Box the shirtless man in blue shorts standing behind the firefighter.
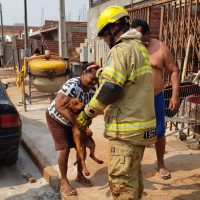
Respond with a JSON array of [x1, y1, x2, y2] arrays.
[[131, 19, 180, 180]]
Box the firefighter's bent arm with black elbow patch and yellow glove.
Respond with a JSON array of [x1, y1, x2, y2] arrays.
[[77, 47, 127, 127]]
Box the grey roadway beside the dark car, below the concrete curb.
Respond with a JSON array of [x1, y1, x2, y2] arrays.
[[0, 147, 59, 200]]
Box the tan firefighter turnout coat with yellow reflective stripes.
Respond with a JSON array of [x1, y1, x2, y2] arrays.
[[86, 29, 156, 145]]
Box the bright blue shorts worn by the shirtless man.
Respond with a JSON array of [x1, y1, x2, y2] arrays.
[[154, 92, 165, 136]]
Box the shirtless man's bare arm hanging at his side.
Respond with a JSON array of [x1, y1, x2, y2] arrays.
[[162, 43, 180, 111]]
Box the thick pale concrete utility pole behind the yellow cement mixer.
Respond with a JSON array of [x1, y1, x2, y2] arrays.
[[59, 0, 67, 57]]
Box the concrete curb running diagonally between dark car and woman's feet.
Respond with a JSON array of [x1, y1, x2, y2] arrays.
[[22, 133, 60, 191]]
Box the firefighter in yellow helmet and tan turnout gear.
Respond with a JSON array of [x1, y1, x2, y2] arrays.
[[77, 6, 156, 200]]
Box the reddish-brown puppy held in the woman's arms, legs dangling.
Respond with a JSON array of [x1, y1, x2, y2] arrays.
[[67, 98, 103, 176]]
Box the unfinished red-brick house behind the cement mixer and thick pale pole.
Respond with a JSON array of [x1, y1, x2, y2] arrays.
[[24, 20, 87, 55]]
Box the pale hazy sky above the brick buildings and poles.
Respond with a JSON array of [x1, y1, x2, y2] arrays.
[[0, 0, 89, 26]]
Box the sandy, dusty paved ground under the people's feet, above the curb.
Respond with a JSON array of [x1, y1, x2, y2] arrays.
[[5, 82, 200, 200]]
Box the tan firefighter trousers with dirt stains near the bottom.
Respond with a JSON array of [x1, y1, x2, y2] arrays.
[[108, 140, 145, 200]]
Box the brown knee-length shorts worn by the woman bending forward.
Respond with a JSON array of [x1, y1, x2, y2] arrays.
[[46, 111, 75, 151]]
